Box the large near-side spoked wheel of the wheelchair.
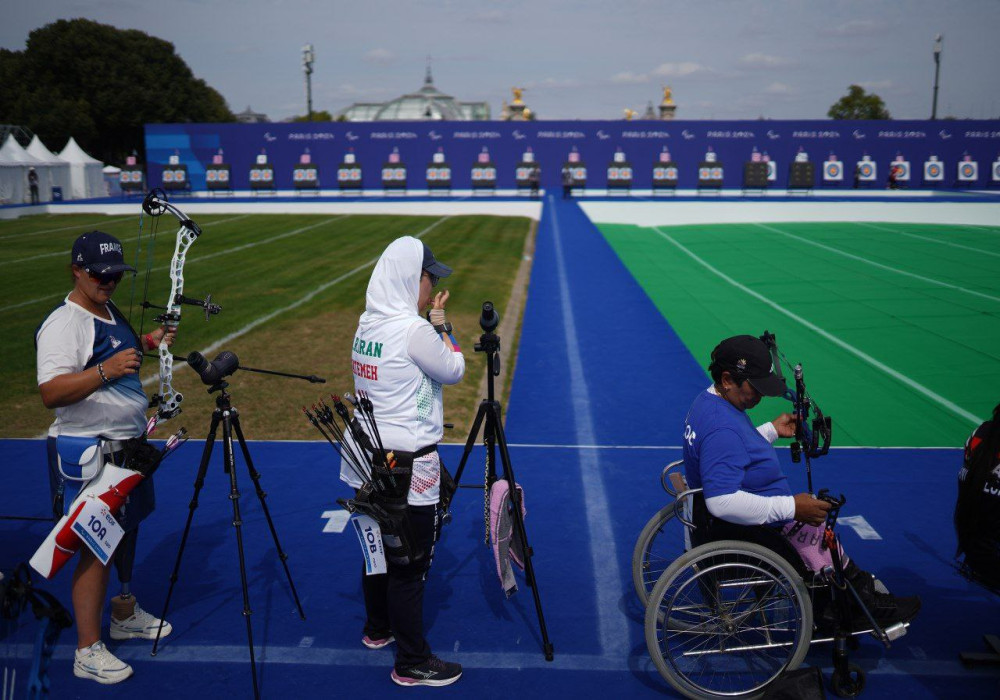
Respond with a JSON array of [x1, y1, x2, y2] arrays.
[[646, 540, 813, 698]]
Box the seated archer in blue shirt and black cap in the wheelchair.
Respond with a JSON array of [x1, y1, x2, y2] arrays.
[[683, 335, 920, 626]]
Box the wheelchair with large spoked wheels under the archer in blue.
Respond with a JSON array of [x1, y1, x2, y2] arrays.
[[632, 461, 909, 699]]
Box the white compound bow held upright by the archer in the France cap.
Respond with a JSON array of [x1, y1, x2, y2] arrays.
[[129, 189, 222, 434]]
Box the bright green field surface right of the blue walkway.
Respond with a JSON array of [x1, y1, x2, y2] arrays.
[[600, 223, 1000, 447]]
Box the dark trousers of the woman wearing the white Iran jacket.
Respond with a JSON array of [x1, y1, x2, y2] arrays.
[[361, 505, 438, 669]]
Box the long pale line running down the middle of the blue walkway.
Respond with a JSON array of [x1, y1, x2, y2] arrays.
[[546, 195, 629, 654]]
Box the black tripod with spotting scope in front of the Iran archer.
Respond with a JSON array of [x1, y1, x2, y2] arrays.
[[455, 302, 553, 661]]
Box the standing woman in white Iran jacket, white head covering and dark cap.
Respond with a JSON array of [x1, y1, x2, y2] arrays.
[[341, 236, 465, 686]]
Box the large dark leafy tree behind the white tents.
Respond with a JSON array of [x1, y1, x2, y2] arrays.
[[0, 19, 234, 163]]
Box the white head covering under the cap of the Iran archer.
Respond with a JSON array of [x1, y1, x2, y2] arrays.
[[360, 236, 424, 328]]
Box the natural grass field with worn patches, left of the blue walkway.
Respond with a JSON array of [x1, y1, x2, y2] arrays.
[[0, 213, 531, 439]]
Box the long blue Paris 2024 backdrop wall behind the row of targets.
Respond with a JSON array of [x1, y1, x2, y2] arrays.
[[146, 120, 1000, 191]]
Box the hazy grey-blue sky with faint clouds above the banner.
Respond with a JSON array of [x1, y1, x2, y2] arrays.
[[0, 0, 1000, 120]]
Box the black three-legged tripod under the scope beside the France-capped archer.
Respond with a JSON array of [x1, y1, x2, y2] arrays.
[[152, 382, 306, 698]]
